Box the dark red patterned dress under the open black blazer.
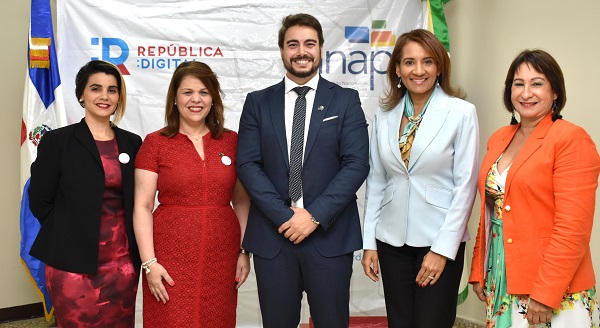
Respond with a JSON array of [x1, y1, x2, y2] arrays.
[[46, 139, 139, 328]]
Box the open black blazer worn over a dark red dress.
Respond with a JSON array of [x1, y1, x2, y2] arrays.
[[29, 120, 142, 274]]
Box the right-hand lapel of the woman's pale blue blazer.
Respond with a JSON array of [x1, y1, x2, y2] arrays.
[[408, 87, 450, 171]]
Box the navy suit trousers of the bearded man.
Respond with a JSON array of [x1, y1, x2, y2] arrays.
[[254, 239, 352, 328]]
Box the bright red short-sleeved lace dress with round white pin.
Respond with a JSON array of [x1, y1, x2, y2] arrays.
[[135, 131, 240, 328]]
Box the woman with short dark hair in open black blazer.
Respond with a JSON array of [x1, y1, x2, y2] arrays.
[[29, 60, 142, 327]]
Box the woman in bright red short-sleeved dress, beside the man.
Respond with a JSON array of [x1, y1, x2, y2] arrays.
[[134, 62, 250, 328]]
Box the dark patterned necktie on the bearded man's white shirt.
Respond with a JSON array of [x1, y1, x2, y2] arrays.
[[289, 87, 310, 202]]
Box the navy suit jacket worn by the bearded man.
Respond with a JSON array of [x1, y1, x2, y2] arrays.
[[236, 78, 369, 259]]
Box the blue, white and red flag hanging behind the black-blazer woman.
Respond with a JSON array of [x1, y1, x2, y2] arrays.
[[21, 0, 66, 320]]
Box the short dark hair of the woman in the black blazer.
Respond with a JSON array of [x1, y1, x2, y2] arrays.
[[75, 60, 127, 124]]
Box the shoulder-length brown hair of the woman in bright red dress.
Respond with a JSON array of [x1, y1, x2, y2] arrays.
[[161, 61, 226, 139]]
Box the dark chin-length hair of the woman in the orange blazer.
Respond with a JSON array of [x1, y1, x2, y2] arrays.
[[503, 49, 567, 121]]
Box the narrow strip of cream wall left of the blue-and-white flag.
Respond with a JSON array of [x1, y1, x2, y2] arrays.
[[0, 0, 39, 309]]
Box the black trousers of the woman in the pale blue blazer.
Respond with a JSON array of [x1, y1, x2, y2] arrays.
[[377, 240, 465, 328]]
